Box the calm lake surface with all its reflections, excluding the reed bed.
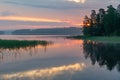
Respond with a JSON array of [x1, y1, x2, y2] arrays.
[[0, 35, 120, 80]]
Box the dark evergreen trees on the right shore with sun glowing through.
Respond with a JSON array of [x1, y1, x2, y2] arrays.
[[83, 4, 120, 36]]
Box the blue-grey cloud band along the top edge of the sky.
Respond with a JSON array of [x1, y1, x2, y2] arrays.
[[4, 0, 85, 9]]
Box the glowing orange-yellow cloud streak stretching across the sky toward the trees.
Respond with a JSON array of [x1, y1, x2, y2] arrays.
[[0, 16, 82, 26]]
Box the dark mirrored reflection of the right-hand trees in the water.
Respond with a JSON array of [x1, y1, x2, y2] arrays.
[[83, 41, 120, 72]]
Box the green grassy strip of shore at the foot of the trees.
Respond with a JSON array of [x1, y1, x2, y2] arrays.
[[68, 36, 120, 43]]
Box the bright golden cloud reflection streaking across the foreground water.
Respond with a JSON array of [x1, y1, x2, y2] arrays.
[[0, 63, 86, 80]]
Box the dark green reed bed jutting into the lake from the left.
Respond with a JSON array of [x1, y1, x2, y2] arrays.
[[0, 39, 50, 49]]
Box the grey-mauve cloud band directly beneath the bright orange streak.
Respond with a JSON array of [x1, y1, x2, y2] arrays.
[[0, 20, 69, 27]]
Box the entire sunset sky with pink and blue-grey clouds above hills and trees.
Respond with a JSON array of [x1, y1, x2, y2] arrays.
[[0, 0, 120, 30]]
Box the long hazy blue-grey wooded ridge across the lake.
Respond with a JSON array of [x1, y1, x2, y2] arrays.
[[11, 27, 82, 35]]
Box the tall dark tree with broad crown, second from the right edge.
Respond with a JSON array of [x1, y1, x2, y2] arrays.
[[104, 5, 117, 36]]
